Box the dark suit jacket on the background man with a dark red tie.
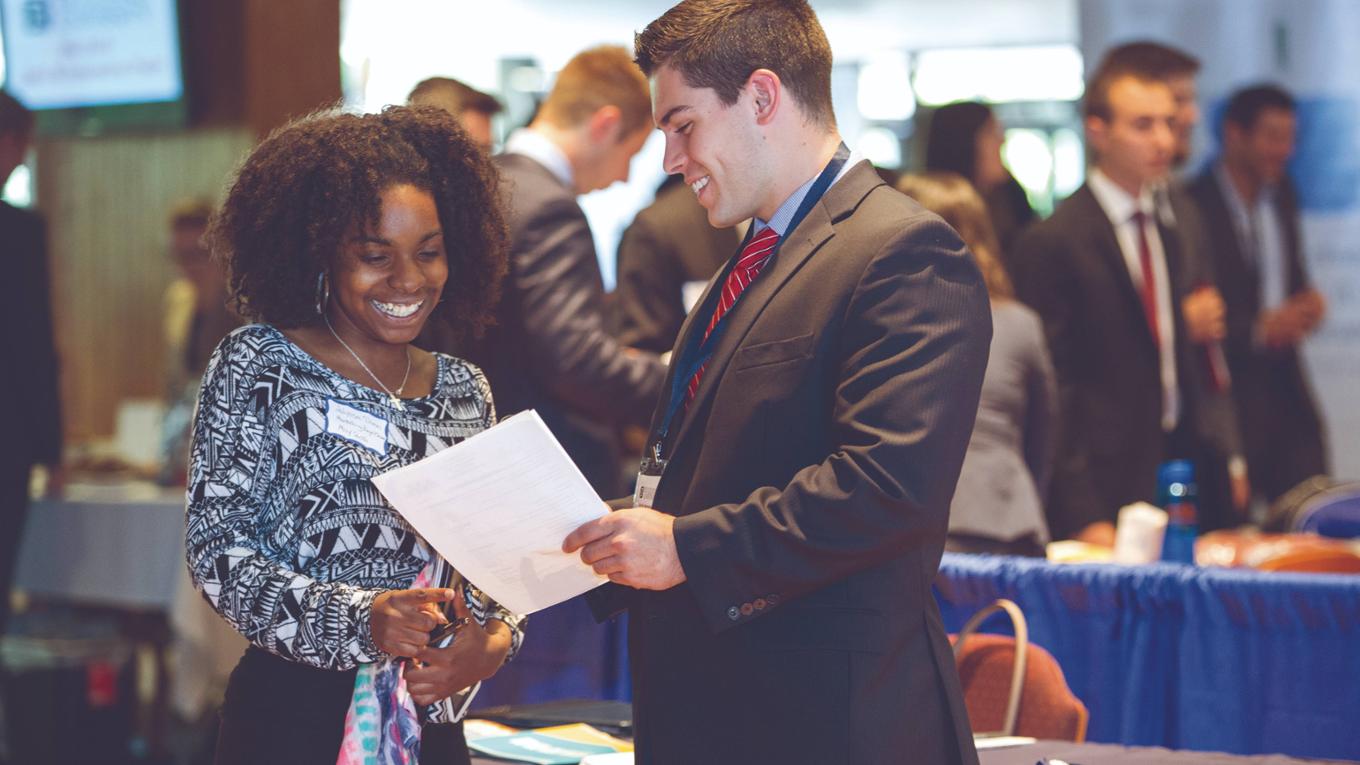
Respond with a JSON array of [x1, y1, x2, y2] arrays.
[[1012, 185, 1236, 539]]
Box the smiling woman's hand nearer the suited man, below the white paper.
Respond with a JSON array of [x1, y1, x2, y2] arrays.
[[405, 591, 510, 705]]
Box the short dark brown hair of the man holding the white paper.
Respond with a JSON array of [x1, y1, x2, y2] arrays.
[[634, 0, 836, 125]]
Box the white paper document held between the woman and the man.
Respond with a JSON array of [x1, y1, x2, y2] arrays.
[[373, 410, 608, 614]]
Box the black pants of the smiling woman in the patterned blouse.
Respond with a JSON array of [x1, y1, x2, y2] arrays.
[[214, 647, 471, 765]]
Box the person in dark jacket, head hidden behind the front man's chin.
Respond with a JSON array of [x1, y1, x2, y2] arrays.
[[613, 176, 741, 354]]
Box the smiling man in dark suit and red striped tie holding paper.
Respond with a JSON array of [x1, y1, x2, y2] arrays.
[[564, 0, 991, 765]]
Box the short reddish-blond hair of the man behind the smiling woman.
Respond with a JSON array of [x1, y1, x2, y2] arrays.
[[539, 45, 651, 135]]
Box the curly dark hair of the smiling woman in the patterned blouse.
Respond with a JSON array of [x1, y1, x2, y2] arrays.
[[208, 106, 507, 338]]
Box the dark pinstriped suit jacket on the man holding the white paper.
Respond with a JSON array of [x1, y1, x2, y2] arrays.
[[597, 163, 991, 765]]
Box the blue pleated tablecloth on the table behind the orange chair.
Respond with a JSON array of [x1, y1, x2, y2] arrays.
[[936, 554, 1360, 760]]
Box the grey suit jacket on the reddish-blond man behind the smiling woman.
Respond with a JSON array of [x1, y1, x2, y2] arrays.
[[427, 154, 665, 497]]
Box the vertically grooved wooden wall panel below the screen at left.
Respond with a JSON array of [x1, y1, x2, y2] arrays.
[[38, 125, 253, 442]]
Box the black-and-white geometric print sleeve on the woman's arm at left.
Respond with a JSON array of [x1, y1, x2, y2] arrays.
[[185, 328, 389, 670]]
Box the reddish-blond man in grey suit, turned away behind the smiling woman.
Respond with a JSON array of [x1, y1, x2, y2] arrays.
[[426, 46, 665, 497]]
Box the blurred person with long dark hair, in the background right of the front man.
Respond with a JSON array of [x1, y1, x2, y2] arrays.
[[926, 101, 1035, 257]]
